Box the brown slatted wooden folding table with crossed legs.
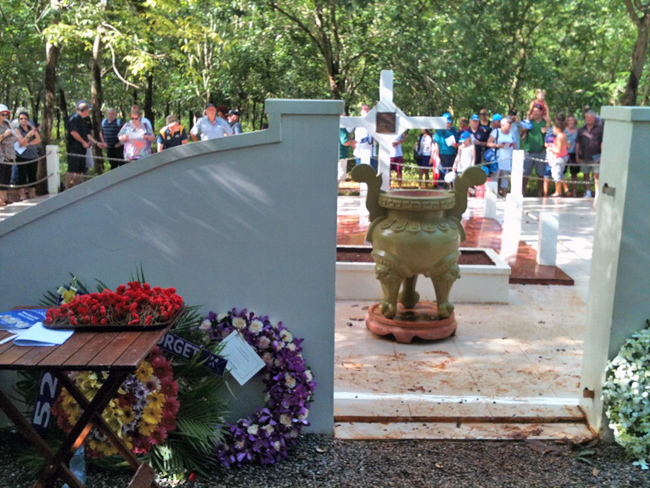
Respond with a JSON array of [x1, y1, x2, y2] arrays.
[[0, 326, 169, 488]]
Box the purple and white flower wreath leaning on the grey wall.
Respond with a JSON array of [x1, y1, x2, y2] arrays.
[[200, 309, 316, 466]]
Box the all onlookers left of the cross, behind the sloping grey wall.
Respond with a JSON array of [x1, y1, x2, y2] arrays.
[[0, 101, 243, 202]]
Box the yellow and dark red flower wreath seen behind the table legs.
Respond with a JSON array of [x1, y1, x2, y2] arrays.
[[52, 348, 180, 458]]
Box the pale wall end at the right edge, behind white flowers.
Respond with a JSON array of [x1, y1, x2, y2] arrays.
[[580, 107, 650, 437]]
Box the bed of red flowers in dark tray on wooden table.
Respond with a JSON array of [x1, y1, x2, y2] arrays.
[[45, 281, 183, 325]]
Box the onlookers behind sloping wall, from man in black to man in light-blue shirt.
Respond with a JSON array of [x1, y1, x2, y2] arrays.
[[65, 101, 243, 189]]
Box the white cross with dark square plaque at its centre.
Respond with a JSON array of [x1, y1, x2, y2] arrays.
[[341, 70, 447, 190]]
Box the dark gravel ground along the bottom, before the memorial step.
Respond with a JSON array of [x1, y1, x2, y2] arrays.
[[0, 435, 650, 488]]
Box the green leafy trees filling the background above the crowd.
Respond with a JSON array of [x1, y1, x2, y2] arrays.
[[0, 0, 650, 137]]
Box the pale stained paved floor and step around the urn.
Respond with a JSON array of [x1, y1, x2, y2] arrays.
[[334, 197, 595, 439]]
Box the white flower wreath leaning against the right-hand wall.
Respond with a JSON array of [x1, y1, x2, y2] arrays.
[[603, 329, 650, 469]]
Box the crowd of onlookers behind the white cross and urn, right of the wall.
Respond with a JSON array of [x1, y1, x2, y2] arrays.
[[338, 89, 603, 197]]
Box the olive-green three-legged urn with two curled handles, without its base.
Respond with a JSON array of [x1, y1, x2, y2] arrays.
[[352, 165, 486, 319]]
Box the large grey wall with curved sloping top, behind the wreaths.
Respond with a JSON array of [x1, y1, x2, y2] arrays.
[[0, 100, 343, 433]]
